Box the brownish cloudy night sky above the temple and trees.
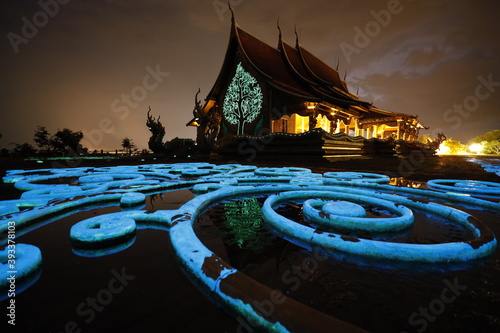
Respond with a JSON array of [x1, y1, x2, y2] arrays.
[[0, 0, 500, 150]]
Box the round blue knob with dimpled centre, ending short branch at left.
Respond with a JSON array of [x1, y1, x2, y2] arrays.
[[70, 215, 137, 248]]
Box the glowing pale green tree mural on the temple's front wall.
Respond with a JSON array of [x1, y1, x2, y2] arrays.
[[222, 62, 262, 135]]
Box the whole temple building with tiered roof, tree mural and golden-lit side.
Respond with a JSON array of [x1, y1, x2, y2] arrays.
[[188, 9, 424, 155]]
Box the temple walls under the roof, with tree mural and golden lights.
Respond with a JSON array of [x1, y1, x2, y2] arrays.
[[214, 56, 418, 140]]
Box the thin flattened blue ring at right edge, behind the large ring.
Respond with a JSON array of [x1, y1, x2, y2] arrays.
[[427, 179, 500, 197]]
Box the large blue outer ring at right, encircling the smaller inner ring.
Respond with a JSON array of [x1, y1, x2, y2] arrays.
[[262, 191, 497, 263]]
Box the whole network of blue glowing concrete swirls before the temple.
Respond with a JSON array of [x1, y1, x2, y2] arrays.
[[0, 163, 500, 332]]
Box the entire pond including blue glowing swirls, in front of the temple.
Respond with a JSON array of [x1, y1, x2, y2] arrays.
[[0, 163, 500, 332]]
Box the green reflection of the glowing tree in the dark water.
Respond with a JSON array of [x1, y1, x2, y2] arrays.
[[223, 198, 270, 250]]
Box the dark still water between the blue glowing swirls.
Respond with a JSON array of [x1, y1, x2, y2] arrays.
[[0, 162, 500, 332]]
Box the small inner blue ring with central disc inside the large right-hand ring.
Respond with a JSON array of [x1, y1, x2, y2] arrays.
[[302, 192, 413, 232]]
